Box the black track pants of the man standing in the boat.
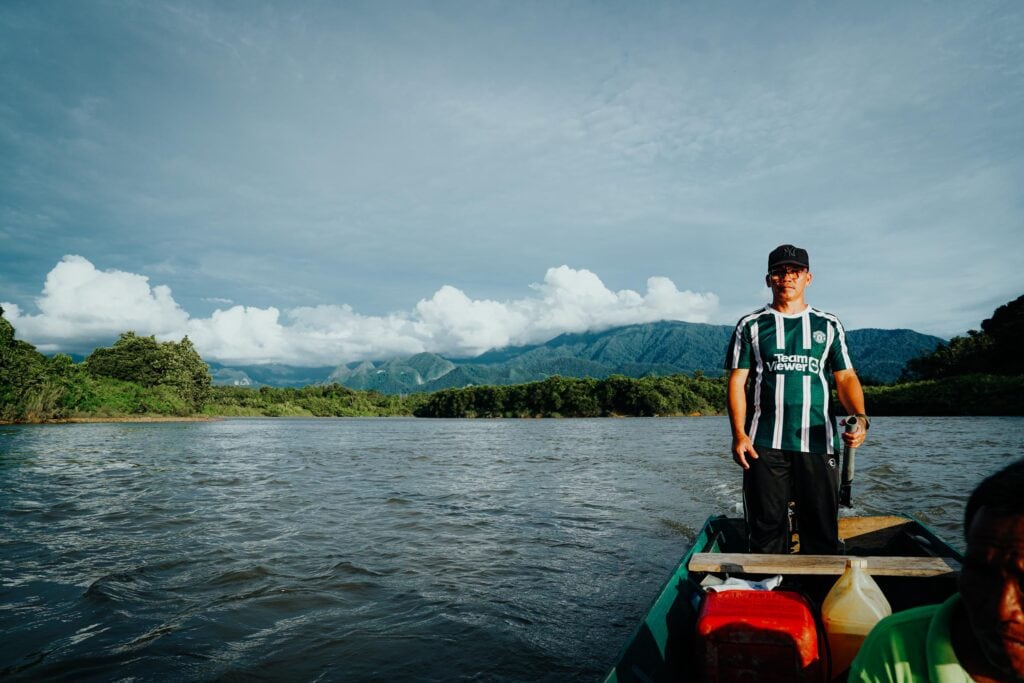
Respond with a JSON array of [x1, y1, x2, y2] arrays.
[[743, 447, 840, 555]]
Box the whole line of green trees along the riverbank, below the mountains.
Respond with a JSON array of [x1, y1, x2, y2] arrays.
[[0, 296, 1024, 423]]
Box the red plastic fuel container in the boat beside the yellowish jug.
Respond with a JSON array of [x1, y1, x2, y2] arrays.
[[696, 591, 825, 683]]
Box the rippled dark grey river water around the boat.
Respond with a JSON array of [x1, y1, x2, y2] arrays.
[[0, 418, 1024, 681]]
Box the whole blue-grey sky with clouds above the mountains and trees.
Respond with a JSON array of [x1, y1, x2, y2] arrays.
[[0, 0, 1024, 365]]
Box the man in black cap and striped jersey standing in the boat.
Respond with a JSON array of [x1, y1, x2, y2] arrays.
[[725, 245, 868, 554]]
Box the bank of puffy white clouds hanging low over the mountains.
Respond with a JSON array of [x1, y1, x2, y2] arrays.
[[3, 255, 718, 366]]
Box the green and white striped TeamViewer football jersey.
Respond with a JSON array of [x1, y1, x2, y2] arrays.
[[725, 306, 853, 454]]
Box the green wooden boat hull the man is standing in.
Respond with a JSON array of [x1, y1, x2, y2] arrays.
[[605, 516, 964, 683]]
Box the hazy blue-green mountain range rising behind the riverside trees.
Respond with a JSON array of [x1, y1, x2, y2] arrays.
[[210, 322, 944, 393]]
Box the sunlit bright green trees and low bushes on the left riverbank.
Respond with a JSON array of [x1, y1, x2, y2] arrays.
[[0, 309, 425, 423]]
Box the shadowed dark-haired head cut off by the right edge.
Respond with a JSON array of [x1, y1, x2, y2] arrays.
[[961, 460, 1024, 680]]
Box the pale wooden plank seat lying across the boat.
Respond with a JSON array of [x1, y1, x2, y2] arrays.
[[689, 553, 961, 577]]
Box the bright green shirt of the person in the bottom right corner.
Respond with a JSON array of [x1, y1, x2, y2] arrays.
[[847, 593, 972, 683]]
